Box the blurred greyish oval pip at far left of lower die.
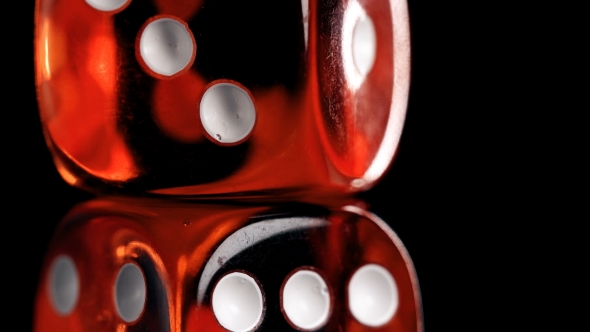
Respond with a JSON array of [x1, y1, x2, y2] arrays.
[[49, 255, 80, 316]]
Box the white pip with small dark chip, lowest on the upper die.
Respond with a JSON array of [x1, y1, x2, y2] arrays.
[[199, 83, 256, 143]]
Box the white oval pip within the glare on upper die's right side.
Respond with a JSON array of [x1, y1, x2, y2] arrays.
[[352, 16, 377, 76]]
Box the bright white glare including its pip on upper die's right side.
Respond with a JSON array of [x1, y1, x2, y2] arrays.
[[342, 1, 377, 90]]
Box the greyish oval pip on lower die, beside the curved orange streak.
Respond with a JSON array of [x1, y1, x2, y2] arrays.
[[115, 263, 146, 323]]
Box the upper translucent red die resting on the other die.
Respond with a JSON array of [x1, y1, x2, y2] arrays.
[[35, 0, 409, 195]]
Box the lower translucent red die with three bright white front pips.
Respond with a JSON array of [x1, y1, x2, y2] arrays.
[[35, 199, 421, 332]]
